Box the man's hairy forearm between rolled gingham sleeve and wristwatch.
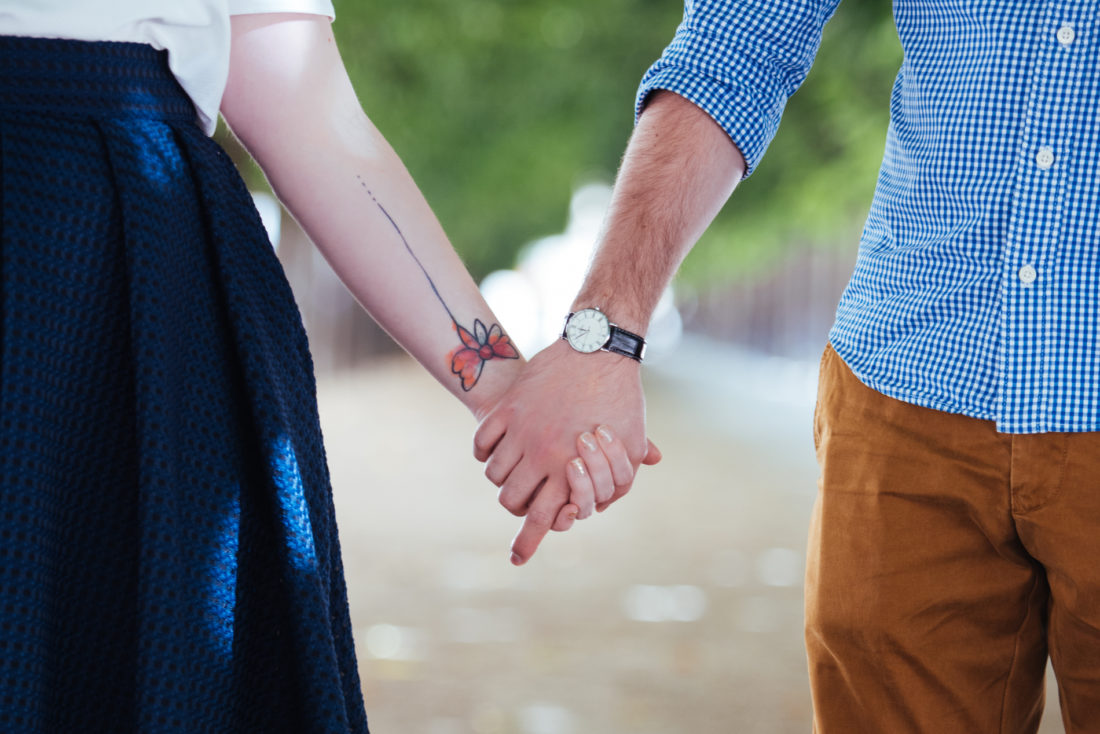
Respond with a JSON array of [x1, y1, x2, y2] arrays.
[[574, 91, 745, 333]]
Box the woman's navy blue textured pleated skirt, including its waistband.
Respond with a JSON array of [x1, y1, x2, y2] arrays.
[[0, 37, 366, 734]]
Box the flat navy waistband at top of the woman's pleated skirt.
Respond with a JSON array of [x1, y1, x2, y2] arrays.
[[0, 36, 196, 122]]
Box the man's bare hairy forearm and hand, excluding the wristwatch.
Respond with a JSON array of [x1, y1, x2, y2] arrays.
[[474, 91, 745, 563]]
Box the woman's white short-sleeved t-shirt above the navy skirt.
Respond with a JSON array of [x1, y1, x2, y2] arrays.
[[0, 0, 336, 133]]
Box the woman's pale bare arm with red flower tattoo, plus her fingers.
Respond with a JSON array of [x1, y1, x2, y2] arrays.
[[221, 13, 629, 545]]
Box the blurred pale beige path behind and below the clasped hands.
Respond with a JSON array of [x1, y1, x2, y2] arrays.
[[320, 342, 1062, 734]]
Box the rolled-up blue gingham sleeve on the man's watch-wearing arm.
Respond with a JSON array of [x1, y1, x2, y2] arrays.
[[635, 0, 839, 176]]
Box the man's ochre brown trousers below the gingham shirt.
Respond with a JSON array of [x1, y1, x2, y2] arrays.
[[806, 348, 1100, 734]]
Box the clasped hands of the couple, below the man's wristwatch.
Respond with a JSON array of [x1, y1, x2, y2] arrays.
[[474, 341, 660, 566]]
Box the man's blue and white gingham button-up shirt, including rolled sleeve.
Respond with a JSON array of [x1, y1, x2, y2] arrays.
[[638, 0, 1100, 432]]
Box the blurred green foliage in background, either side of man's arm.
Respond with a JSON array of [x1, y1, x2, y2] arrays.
[[321, 0, 901, 285]]
